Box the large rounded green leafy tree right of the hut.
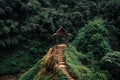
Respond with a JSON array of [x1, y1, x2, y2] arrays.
[[72, 19, 111, 58]]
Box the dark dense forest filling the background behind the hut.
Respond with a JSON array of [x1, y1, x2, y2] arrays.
[[0, 0, 120, 52]]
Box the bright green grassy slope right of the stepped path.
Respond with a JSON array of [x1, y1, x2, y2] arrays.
[[65, 45, 107, 80]]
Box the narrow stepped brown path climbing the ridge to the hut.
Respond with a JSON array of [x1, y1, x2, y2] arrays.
[[57, 44, 75, 80]]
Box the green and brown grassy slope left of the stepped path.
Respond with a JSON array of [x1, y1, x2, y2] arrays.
[[19, 49, 68, 80]]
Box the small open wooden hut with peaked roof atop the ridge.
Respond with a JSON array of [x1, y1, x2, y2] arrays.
[[52, 26, 71, 43]]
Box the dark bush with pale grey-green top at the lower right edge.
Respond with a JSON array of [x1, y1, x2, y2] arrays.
[[100, 51, 120, 80]]
